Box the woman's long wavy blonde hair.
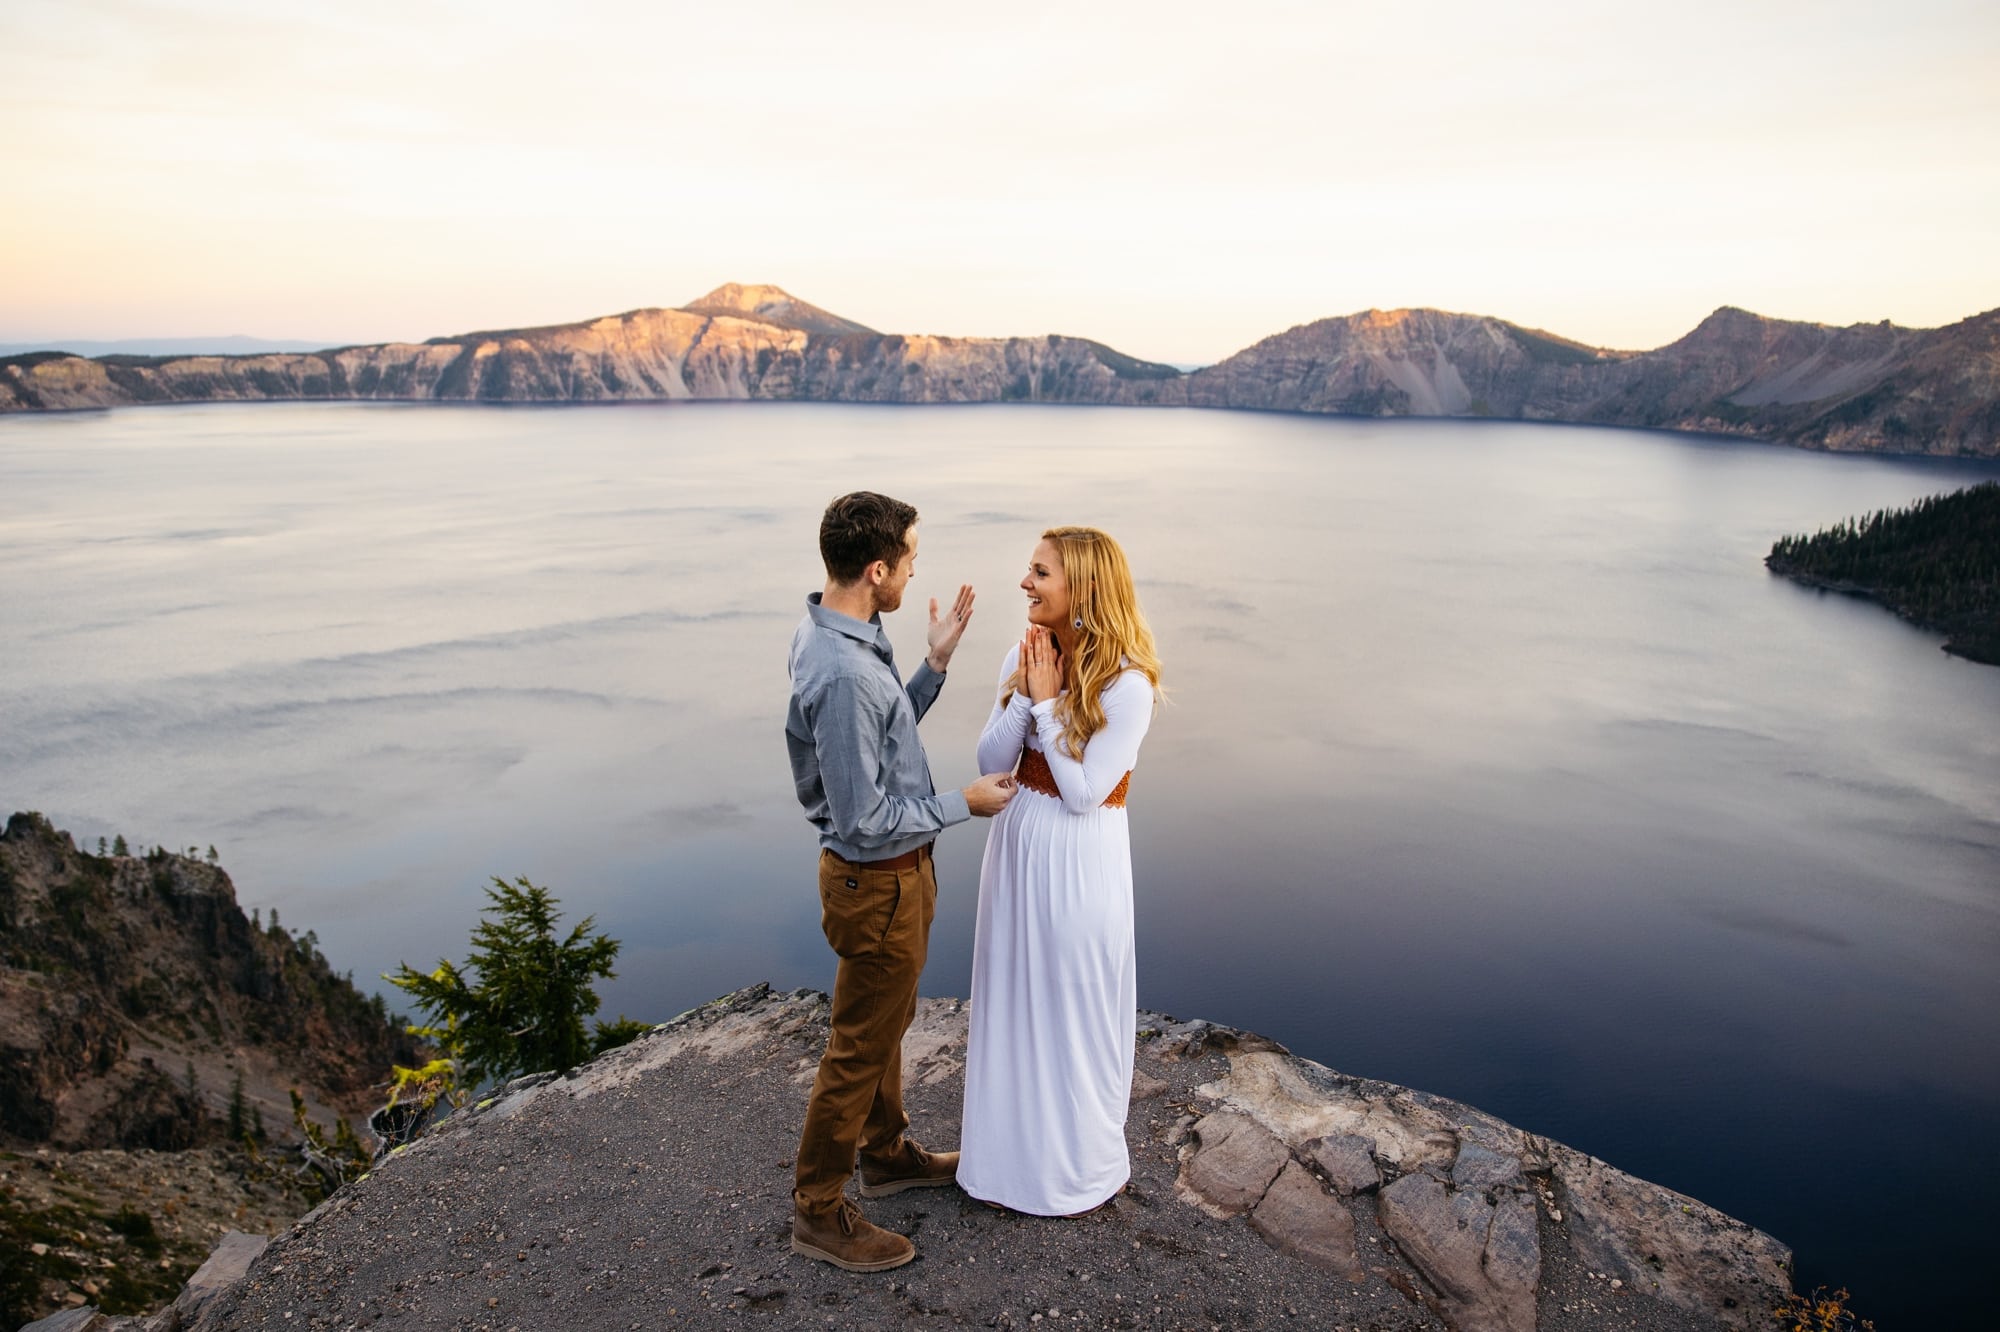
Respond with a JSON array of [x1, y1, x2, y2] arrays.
[[1002, 528, 1164, 758]]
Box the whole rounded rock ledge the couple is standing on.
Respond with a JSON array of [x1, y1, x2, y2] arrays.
[[40, 986, 1790, 1332]]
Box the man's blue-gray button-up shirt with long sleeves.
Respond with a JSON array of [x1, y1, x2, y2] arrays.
[[784, 592, 972, 860]]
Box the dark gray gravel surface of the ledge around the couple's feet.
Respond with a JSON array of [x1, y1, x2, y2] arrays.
[[160, 986, 1752, 1332]]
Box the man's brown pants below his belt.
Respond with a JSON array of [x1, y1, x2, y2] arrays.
[[792, 846, 938, 1212]]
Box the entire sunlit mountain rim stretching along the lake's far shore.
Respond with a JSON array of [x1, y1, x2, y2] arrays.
[[0, 282, 2000, 458]]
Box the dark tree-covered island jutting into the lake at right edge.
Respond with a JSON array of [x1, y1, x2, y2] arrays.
[[1764, 482, 2000, 666]]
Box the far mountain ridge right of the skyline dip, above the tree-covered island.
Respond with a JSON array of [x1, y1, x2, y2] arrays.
[[1160, 308, 2000, 458]]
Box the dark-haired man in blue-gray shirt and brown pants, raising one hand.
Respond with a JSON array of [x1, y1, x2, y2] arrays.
[[784, 490, 1014, 1272]]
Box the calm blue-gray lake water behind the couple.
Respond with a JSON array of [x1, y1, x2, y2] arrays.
[[0, 404, 2000, 1328]]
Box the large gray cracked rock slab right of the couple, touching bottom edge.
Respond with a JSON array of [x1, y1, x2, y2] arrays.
[[1378, 1174, 1542, 1332]]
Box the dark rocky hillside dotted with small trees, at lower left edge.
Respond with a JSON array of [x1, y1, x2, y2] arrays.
[[0, 814, 418, 1150]]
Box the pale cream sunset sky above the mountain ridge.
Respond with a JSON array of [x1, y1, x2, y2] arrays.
[[0, 0, 2000, 364]]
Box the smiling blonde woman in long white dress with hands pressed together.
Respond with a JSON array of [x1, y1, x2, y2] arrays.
[[958, 528, 1160, 1216]]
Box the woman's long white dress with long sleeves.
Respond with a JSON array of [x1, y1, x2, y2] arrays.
[[958, 646, 1152, 1216]]
